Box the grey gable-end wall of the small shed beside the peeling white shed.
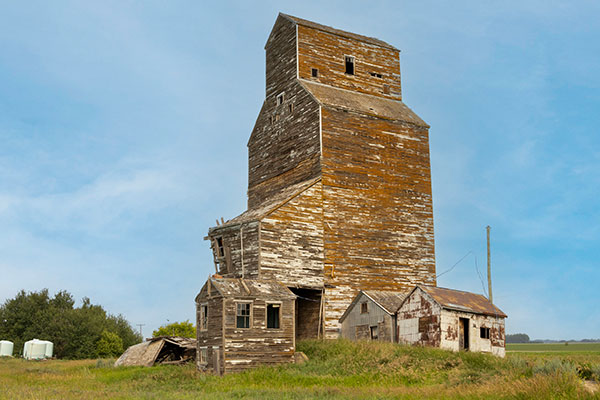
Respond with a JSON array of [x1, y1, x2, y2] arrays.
[[341, 293, 396, 342]]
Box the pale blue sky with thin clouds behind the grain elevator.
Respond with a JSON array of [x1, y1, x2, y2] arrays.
[[0, 0, 600, 339]]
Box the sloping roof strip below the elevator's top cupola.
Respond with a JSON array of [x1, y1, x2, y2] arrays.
[[299, 79, 429, 128]]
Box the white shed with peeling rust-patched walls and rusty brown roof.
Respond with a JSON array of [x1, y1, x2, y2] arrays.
[[397, 285, 506, 357]]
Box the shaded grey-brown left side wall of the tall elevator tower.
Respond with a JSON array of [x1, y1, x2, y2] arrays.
[[248, 18, 320, 208]]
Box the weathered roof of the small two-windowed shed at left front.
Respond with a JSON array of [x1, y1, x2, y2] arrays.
[[196, 276, 296, 301]]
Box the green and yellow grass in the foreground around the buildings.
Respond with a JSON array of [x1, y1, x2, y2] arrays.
[[0, 340, 600, 400]]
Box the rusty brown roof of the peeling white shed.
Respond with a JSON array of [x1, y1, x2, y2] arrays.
[[411, 285, 507, 318]]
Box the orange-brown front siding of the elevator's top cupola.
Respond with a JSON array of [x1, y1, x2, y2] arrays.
[[298, 25, 402, 100]]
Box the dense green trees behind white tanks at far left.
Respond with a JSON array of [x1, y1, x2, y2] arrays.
[[0, 289, 142, 359]]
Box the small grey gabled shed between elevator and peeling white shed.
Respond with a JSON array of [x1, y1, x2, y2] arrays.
[[340, 290, 408, 342]]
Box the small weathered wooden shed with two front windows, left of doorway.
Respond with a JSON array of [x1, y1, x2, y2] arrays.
[[196, 277, 296, 374]]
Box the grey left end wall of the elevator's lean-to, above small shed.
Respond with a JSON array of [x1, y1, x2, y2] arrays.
[[209, 221, 259, 279]]
